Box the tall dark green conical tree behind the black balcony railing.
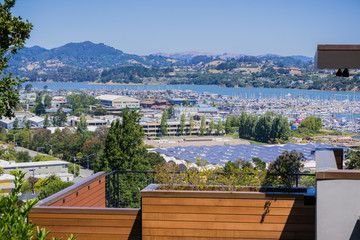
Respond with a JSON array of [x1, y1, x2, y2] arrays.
[[100, 108, 149, 172]]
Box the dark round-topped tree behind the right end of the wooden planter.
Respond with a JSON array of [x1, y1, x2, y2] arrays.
[[266, 150, 304, 187]]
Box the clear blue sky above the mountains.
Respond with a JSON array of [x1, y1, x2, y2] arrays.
[[14, 0, 360, 57]]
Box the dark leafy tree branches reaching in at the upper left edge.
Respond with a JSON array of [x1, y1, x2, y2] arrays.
[[0, 0, 33, 118]]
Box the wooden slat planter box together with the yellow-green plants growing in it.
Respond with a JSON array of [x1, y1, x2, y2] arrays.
[[141, 153, 315, 239]]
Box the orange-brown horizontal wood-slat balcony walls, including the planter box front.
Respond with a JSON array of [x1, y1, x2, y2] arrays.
[[29, 172, 315, 240]]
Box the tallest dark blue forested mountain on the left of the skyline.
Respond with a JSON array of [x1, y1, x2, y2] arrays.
[[8, 41, 182, 76]]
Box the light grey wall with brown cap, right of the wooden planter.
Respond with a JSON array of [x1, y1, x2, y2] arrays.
[[316, 149, 360, 240]]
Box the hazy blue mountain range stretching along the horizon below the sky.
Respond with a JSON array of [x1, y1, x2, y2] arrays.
[[8, 41, 312, 74]]
